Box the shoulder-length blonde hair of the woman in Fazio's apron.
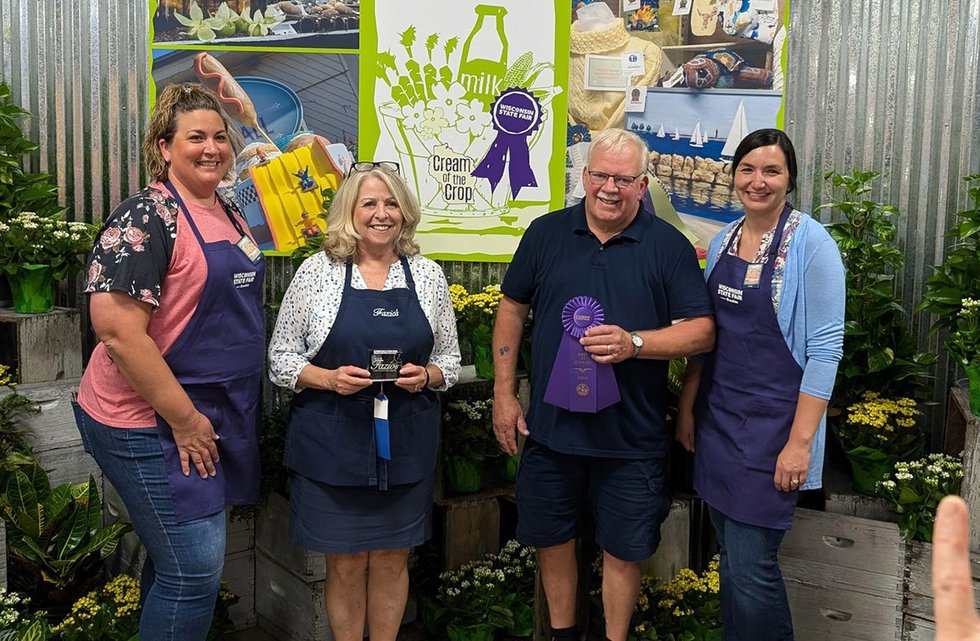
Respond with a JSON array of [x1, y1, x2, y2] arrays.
[[323, 167, 422, 261]]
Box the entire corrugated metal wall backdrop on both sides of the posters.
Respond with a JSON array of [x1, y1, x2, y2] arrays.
[[0, 0, 980, 433]]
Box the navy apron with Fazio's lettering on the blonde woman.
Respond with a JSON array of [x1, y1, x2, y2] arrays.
[[285, 257, 439, 490]]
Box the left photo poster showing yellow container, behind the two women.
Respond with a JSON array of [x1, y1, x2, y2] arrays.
[[149, 0, 359, 255]]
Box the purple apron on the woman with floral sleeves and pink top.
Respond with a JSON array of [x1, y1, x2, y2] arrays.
[[157, 181, 265, 523]]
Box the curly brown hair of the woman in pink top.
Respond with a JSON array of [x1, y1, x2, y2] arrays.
[[143, 82, 244, 180]]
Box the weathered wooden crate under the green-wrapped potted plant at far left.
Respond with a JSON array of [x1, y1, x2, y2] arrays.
[[0, 307, 82, 383]]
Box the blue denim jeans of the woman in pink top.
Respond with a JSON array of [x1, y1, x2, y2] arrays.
[[75, 405, 225, 641]]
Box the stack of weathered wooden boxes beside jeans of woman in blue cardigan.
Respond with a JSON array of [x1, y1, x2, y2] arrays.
[[780, 509, 905, 641]]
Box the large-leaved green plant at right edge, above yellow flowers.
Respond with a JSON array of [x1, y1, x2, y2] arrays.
[[919, 174, 980, 415]]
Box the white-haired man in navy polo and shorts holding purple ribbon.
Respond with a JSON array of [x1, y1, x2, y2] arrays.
[[493, 129, 714, 641]]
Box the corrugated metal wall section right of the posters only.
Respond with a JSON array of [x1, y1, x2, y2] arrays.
[[785, 0, 980, 440]]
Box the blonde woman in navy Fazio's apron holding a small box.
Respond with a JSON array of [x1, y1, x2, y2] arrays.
[[269, 162, 460, 641]]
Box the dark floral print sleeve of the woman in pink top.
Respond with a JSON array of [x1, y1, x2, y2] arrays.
[[84, 187, 177, 307]]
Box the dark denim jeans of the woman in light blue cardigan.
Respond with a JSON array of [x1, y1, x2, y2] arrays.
[[709, 507, 793, 641]]
